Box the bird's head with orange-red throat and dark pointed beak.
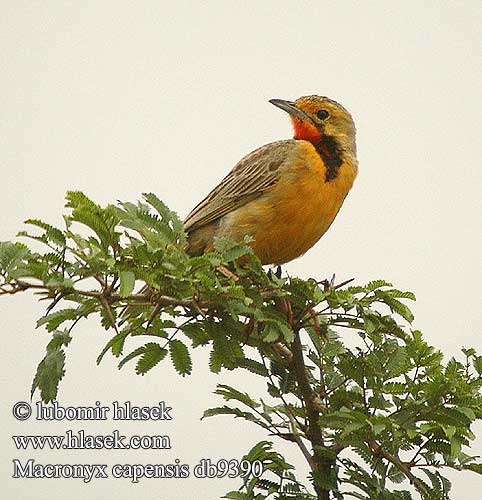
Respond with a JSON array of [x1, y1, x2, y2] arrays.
[[269, 95, 356, 155]]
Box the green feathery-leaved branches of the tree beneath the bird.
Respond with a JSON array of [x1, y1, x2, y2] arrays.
[[0, 192, 482, 500]]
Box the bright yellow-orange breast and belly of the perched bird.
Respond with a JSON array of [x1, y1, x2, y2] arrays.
[[218, 144, 357, 264]]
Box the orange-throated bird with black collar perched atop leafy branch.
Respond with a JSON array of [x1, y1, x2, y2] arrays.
[[184, 95, 358, 264]]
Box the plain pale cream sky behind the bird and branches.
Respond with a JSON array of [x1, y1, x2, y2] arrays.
[[0, 0, 482, 500]]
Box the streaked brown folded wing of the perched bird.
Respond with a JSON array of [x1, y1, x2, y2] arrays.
[[184, 140, 297, 232]]
